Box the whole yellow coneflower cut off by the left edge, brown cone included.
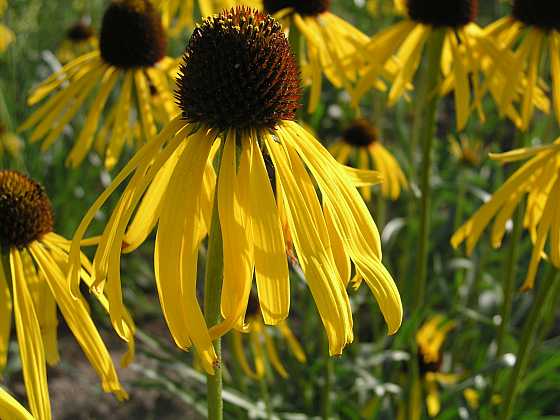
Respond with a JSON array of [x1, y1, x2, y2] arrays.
[[0, 170, 134, 420]]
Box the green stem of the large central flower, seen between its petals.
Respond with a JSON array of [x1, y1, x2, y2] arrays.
[[204, 146, 224, 420]]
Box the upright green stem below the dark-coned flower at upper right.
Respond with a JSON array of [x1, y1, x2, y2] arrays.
[[412, 29, 445, 311]]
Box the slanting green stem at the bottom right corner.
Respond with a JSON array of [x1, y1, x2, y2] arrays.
[[500, 267, 558, 420]]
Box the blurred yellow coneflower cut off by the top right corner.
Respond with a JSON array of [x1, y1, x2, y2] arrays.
[[484, 0, 560, 130]]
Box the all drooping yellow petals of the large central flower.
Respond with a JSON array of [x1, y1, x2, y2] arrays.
[[70, 119, 402, 372]]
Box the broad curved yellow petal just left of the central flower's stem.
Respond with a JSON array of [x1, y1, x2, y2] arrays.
[[154, 132, 217, 374]]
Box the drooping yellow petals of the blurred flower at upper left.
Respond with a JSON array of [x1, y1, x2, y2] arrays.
[[19, 51, 178, 168]]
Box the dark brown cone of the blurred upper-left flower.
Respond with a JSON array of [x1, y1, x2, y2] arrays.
[[99, 0, 167, 69]]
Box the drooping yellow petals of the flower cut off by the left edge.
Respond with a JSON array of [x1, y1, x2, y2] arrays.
[[0, 233, 134, 419]]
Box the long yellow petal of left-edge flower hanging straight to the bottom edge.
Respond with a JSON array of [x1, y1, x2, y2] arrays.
[[10, 248, 51, 420]]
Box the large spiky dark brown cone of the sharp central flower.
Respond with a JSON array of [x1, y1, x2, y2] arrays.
[[176, 7, 301, 130]]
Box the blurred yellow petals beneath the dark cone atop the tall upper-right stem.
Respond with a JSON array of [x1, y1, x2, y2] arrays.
[[349, 19, 481, 130]]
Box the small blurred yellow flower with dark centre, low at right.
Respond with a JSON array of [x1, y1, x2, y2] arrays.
[[416, 315, 460, 417]]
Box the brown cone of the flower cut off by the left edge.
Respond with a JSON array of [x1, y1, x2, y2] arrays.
[[0, 170, 54, 250]]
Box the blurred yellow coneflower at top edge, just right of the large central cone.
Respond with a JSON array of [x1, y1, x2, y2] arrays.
[[256, 0, 374, 112]]
